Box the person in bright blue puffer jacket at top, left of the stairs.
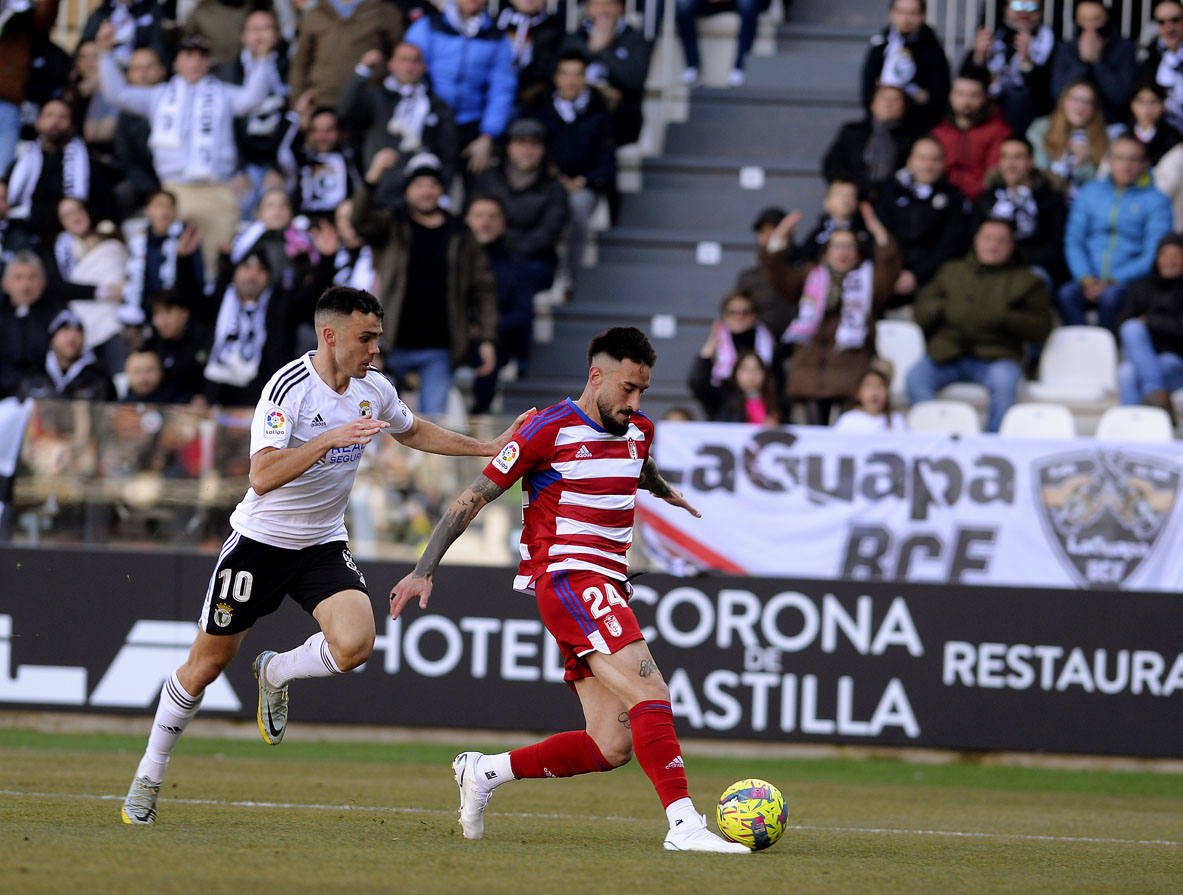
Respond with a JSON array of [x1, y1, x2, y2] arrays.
[[406, 0, 517, 174]]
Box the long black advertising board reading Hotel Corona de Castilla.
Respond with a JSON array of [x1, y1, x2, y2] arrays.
[[0, 547, 1183, 757]]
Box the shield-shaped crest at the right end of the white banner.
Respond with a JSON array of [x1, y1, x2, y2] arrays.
[[1032, 450, 1181, 588]]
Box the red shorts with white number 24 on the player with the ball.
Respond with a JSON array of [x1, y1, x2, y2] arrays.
[[534, 571, 644, 682]]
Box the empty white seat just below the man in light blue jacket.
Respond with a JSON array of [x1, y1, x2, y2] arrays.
[[1027, 326, 1117, 402]]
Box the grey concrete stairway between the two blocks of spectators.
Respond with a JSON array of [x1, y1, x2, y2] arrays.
[[504, 0, 886, 417]]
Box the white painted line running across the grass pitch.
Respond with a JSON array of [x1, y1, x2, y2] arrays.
[[0, 790, 1183, 847]]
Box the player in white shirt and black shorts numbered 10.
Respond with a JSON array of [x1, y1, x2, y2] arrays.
[[121, 286, 525, 824]]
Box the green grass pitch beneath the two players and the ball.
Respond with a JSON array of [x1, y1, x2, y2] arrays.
[[0, 729, 1183, 895]]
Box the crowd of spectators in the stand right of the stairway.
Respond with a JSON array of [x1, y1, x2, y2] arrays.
[[689, 0, 1183, 432]]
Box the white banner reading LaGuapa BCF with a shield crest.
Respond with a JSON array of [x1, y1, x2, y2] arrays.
[[638, 423, 1183, 591]]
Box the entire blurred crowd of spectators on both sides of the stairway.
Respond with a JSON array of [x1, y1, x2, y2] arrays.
[[0, 0, 1183, 550]]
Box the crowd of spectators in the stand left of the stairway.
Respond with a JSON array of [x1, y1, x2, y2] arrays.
[[0, 0, 652, 414]]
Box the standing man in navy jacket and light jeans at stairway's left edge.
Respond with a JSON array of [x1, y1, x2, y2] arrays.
[[525, 48, 616, 292]]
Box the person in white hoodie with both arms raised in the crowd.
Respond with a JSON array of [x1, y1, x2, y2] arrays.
[[96, 25, 271, 275]]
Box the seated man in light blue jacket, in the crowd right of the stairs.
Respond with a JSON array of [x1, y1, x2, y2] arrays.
[[1056, 136, 1171, 330]]
